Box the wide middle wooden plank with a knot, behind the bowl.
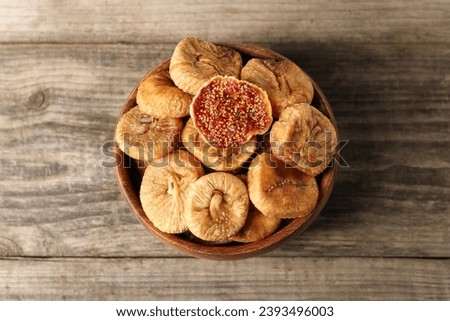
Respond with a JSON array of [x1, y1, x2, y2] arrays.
[[0, 43, 450, 257]]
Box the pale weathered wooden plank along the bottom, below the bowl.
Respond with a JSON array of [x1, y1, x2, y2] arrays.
[[0, 258, 450, 300]]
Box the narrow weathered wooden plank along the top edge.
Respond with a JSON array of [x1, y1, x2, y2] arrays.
[[0, 0, 450, 43]]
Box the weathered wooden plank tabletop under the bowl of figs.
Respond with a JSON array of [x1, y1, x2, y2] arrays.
[[0, 0, 450, 300]]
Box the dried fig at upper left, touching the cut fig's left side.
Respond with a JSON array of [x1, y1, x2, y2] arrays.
[[136, 71, 192, 118]]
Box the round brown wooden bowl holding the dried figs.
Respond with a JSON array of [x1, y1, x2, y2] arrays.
[[115, 43, 339, 260]]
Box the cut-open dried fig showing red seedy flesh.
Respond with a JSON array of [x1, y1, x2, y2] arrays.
[[190, 76, 272, 149]]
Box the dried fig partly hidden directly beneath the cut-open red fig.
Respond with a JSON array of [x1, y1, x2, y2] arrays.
[[181, 118, 258, 172]]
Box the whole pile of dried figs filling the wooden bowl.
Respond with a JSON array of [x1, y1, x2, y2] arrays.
[[115, 38, 337, 244]]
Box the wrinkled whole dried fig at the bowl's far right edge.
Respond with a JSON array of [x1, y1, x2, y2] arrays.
[[270, 104, 337, 176]]
